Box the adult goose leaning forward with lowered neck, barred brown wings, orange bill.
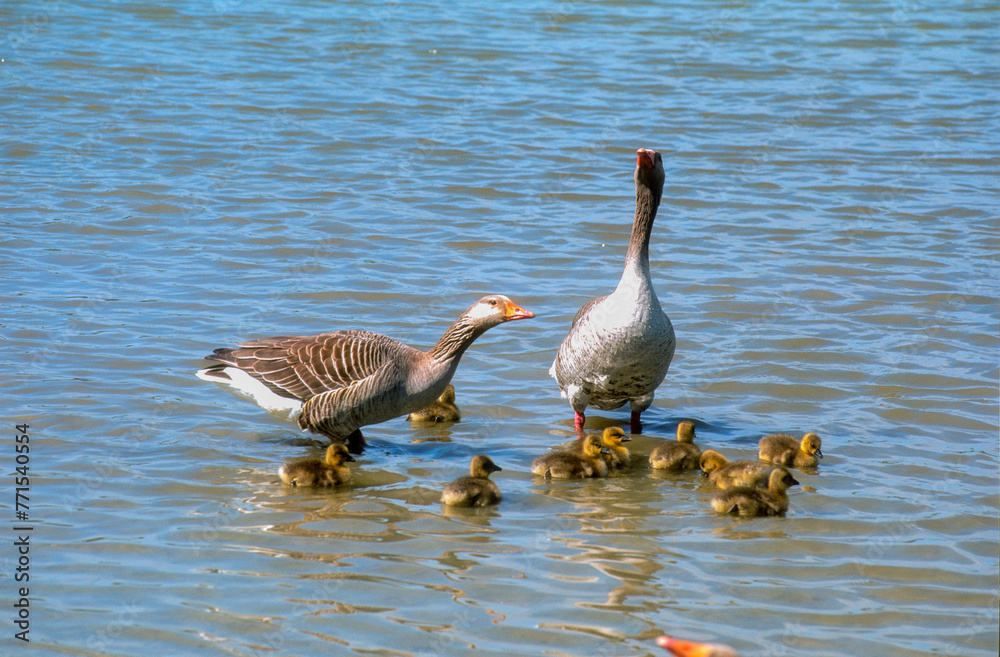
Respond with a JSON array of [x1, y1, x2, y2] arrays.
[[197, 294, 535, 451]]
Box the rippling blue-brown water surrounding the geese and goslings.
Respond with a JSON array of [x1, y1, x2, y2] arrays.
[[0, 1, 1000, 656]]
